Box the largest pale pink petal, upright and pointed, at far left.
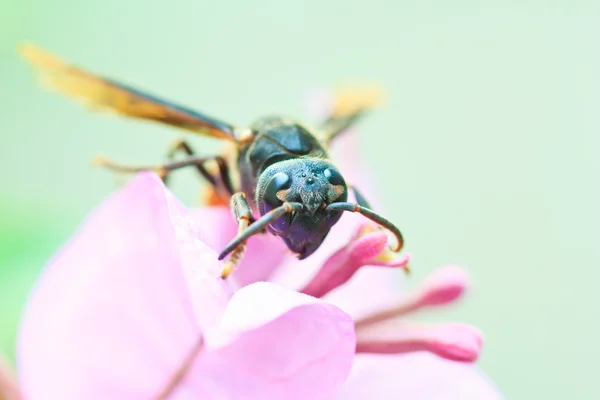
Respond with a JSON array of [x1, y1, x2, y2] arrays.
[[17, 174, 231, 400]]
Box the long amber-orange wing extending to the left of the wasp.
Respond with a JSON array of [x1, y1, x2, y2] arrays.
[[20, 44, 235, 140]]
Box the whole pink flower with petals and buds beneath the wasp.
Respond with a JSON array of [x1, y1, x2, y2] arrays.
[[10, 170, 498, 400]]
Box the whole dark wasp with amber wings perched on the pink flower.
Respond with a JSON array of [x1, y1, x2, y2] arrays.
[[21, 44, 404, 278]]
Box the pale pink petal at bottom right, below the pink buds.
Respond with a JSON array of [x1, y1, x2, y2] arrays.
[[336, 353, 503, 400]]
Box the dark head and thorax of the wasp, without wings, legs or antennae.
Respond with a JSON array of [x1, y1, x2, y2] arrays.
[[234, 118, 348, 259]]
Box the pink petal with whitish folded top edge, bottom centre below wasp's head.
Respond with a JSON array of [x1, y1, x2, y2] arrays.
[[190, 283, 355, 400]]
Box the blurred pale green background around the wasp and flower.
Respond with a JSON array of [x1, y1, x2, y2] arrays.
[[0, 0, 600, 399]]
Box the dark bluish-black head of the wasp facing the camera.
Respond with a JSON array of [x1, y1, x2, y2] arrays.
[[256, 158, 348, 259]]
